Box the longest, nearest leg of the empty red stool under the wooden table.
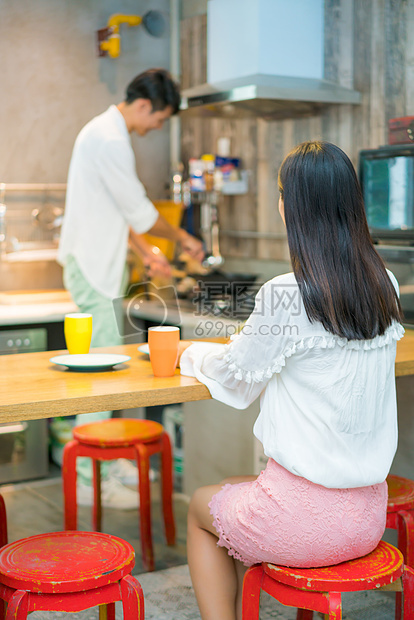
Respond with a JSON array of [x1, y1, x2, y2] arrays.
[[135, 444, 154, 571]]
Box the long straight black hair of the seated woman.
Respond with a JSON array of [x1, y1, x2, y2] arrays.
[[279, 142, 402, 340]]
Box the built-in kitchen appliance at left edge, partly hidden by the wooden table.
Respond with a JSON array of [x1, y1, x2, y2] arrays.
[[0, 327, 49, 484]]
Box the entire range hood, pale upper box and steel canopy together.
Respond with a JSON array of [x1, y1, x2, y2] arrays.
[[182, 0, 362, 119]]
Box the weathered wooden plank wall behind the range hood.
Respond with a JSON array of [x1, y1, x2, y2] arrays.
[[182, 0, 414, 260]]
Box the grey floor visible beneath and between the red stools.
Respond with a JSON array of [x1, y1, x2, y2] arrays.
[[0, 478, 402, 620]]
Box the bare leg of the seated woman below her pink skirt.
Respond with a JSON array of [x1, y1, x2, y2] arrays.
[[187, 476, 255, 620]]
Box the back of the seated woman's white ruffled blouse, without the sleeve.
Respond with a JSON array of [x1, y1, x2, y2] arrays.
[[258, 274, 404, 488]]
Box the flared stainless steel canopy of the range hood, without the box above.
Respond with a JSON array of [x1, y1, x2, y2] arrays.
[[181, 74, 361, 119]]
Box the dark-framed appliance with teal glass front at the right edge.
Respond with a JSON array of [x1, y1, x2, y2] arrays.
[[359, 144, 414, 243]]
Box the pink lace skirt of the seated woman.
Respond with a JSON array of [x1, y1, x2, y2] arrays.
[[209, 459, 388, 568]]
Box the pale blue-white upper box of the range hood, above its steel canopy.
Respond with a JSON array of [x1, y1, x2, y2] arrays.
[[207, 0, 324, 83]]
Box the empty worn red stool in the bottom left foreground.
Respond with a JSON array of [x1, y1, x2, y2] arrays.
[[0, 532, 144, 620]]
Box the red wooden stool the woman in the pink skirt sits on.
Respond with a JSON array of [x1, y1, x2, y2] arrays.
[[242, 541, 414, 620]]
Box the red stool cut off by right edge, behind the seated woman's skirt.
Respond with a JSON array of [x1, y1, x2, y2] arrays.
[[386, 475, 414, 568]]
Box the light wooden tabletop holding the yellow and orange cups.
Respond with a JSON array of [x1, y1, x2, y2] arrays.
[[0, 330, 414, 422]]
